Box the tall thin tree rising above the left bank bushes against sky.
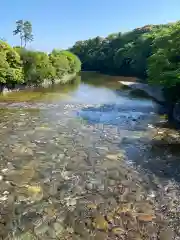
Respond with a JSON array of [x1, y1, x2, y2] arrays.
[[13, 20, 33, 47]]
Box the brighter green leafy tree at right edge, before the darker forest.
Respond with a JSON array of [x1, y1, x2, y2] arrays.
[[148, 22, 180, 88]]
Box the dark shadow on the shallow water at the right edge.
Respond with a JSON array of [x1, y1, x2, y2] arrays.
[[125, 135, 180, 182]]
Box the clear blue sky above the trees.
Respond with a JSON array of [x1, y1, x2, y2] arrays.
[[0, 0, 180, 51]]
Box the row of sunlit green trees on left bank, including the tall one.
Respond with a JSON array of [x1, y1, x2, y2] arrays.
[[0, 20, 81, 87]]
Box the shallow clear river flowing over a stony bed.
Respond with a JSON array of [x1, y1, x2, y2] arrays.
[[0, 73, 180, 240]]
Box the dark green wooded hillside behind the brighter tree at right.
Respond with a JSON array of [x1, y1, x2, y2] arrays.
[[70, 26, 154, 78]]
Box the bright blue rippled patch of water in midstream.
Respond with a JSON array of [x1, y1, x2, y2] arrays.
[[78, 104, 154, 130]]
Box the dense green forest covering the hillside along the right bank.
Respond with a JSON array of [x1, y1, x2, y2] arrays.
[[69, 21, 180, 101]]
